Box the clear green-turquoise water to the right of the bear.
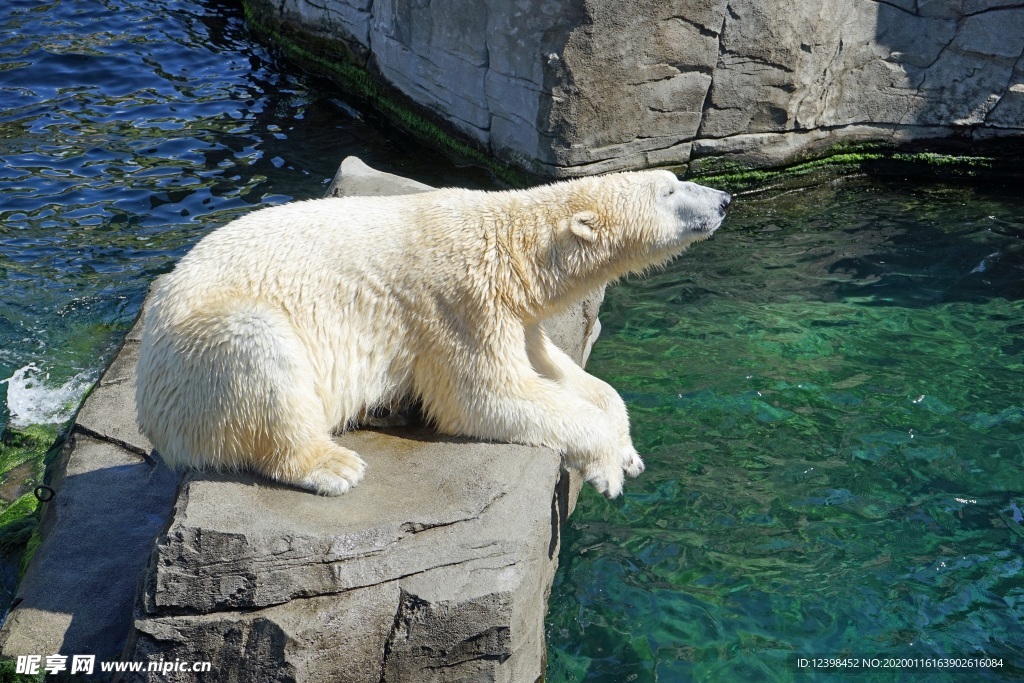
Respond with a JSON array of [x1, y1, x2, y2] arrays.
[[548, 178, 1024, 682]]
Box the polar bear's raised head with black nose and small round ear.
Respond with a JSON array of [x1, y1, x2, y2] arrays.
[[562, 171, 731, 280]]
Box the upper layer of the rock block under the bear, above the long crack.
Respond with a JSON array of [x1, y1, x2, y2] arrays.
[[146, 436, 560, 612]]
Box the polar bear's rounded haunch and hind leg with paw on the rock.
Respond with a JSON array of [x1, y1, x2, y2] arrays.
[[135, 296, 365, 496]]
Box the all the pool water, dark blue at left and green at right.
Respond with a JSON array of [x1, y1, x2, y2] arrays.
[[0, 0, 1024, 681]]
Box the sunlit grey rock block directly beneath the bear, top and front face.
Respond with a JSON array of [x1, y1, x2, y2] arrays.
[[126, 430, 572, 681]]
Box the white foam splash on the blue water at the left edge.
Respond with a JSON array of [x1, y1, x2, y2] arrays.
[[0, 362, 95, 427]]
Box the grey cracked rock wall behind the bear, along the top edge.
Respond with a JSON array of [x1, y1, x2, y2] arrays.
[[249, 0, 1024, 177]]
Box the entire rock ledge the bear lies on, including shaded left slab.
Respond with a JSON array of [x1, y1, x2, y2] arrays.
[[0, 159, 600, 682]]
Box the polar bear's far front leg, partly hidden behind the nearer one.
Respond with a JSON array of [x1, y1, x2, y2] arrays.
[[526, 325, 644, 477]]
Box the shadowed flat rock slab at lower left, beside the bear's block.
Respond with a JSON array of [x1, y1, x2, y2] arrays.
[[0, 434, 178, 660]]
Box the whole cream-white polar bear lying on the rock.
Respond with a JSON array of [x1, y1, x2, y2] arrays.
[[136, 171, 729, 498]]
